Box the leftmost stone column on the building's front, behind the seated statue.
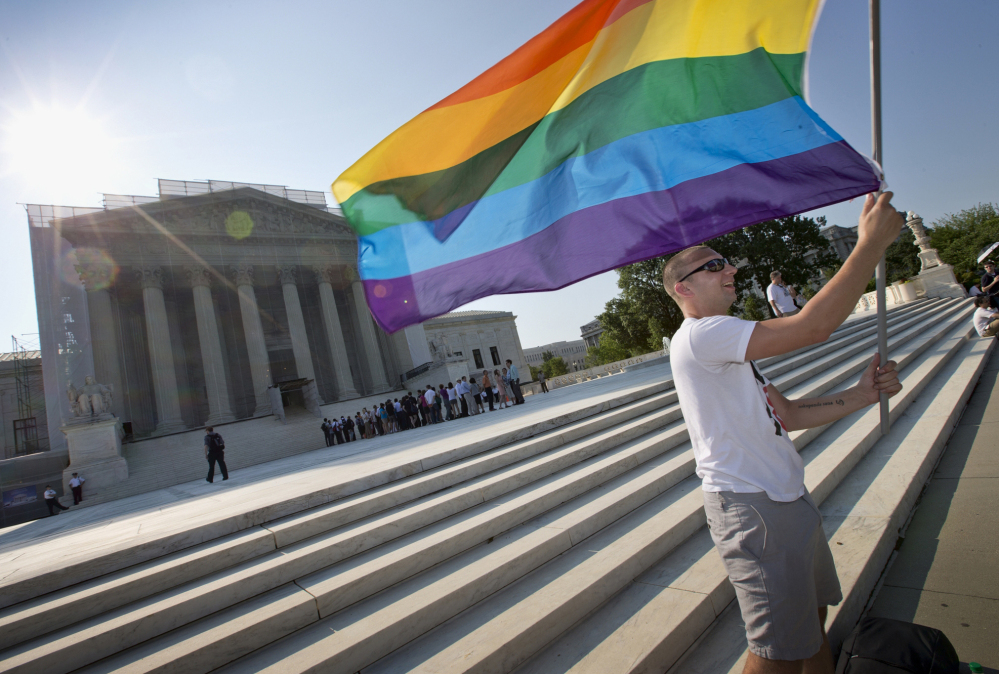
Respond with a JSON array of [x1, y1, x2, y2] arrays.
[[76, 263, 125, 419]]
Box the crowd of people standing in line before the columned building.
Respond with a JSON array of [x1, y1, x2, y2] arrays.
[[321, 360, 524, 447]]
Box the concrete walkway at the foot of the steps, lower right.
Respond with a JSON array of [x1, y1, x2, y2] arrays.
[[870, 350, 999, 674]]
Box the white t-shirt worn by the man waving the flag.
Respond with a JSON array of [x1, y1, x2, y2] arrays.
[[670, 316, 805, 502]]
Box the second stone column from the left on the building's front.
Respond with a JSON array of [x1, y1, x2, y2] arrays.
[[139, 265, 186, 433]]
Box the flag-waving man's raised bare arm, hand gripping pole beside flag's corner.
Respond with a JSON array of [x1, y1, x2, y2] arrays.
[[746, 192, 903, 361]]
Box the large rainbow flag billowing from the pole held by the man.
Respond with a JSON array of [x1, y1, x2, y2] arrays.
[[333, 0, 879, 331]]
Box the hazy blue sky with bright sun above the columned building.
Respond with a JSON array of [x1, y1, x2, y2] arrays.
[[0, 0, 999, 351]]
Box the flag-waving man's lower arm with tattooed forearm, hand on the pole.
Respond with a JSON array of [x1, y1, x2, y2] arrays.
[[767, 354, 902, 431]]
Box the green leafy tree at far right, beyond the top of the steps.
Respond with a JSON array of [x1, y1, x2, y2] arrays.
[[930, 203, 999, 287]]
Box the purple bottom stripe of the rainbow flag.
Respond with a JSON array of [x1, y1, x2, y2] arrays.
[[364, 141, 879, 332]]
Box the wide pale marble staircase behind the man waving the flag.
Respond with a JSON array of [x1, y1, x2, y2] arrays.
[[0, 300, 995, 674]]
